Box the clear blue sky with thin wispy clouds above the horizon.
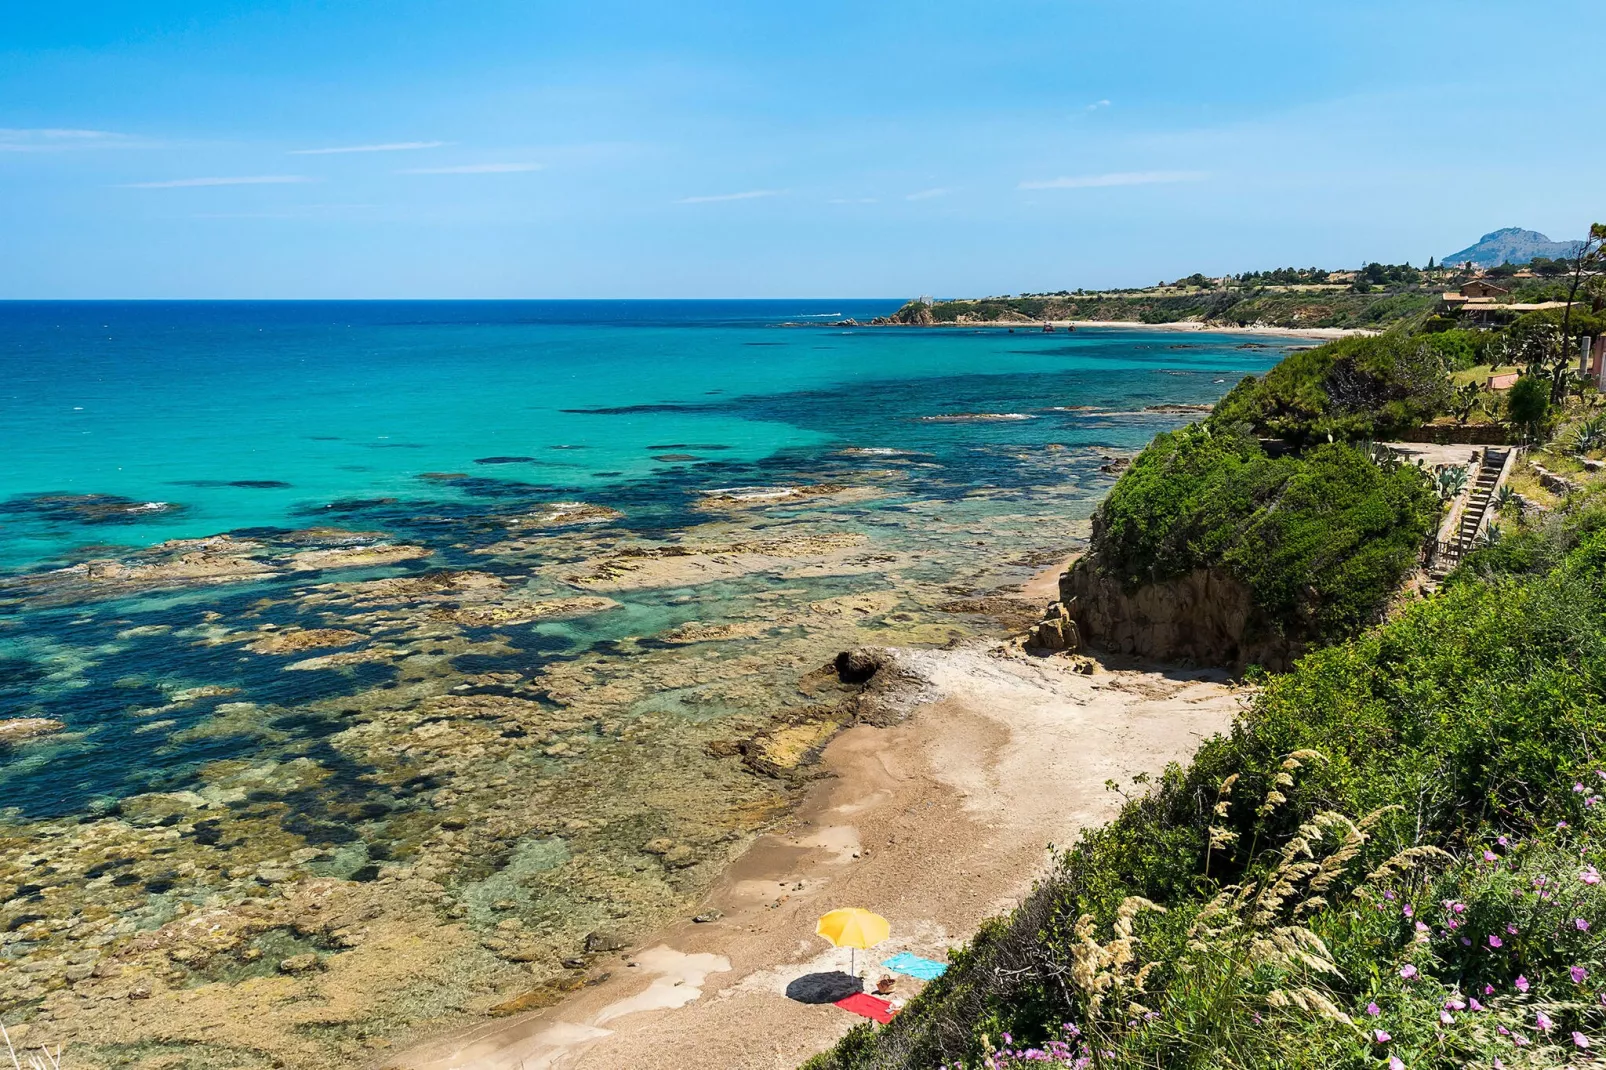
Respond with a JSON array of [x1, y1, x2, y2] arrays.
[[0, 0, 1606, 297]]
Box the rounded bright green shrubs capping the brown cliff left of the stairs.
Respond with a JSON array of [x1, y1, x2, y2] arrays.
[[1092, 421, 1441, 641]]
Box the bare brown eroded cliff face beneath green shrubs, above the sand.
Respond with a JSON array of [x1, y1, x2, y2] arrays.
[[1060, 557, 1304, 672]]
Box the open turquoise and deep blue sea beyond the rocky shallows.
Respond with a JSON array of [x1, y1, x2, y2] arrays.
[[0, 300, 1283, 570]]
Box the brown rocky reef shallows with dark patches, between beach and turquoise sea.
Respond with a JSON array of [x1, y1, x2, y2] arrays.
[[0, 448, 1107, 1070]]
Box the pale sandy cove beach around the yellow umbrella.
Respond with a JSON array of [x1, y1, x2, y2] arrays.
[[395, 644, 1243, 1070]]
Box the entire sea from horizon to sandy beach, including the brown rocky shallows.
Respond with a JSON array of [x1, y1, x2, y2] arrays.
[[0, 302, 1286, 1065]]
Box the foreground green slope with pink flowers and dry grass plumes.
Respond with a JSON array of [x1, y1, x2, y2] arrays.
[[809, 488, 1606, 1070]]
